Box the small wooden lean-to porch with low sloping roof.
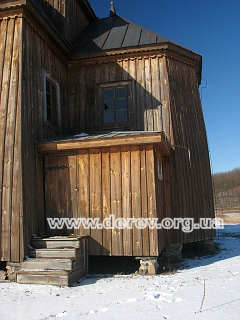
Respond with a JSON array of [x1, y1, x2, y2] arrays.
[[38, 132, 171, 257]]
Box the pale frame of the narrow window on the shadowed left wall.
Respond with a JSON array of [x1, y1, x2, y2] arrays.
[[43, 70, 62, 132]]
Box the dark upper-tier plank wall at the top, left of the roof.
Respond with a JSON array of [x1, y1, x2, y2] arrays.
[[38, 0, 89, 44]]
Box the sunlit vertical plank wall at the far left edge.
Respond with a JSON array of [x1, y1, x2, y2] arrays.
[[0, 16, 22, 261]]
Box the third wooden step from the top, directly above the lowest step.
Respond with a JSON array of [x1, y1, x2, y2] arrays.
[[21, 258, 74, 271]]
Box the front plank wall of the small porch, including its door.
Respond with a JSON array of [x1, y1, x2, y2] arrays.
[[45, 145, 166, 256]]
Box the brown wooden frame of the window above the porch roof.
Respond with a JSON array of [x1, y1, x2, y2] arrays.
[[99, 80, 132, 129]]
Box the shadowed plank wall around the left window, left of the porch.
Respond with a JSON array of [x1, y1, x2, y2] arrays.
[[22, 17, 68, 258]]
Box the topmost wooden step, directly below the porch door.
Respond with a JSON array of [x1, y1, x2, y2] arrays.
[[32, 237, 82, 249]]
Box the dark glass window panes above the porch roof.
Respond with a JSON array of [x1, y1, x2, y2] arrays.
[[104, 86, 128, 123]]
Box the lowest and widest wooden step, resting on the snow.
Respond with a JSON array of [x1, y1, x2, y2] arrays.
[[17, 268, 85, 286]]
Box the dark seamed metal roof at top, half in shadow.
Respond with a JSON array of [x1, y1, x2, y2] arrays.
[[74, 15, 170, 52]]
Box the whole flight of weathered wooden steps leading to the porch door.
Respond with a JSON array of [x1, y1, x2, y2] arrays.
[[17, 237, 88, 286]]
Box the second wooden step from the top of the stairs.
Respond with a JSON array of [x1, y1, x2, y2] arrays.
[[29, 248, 83, 260]]
